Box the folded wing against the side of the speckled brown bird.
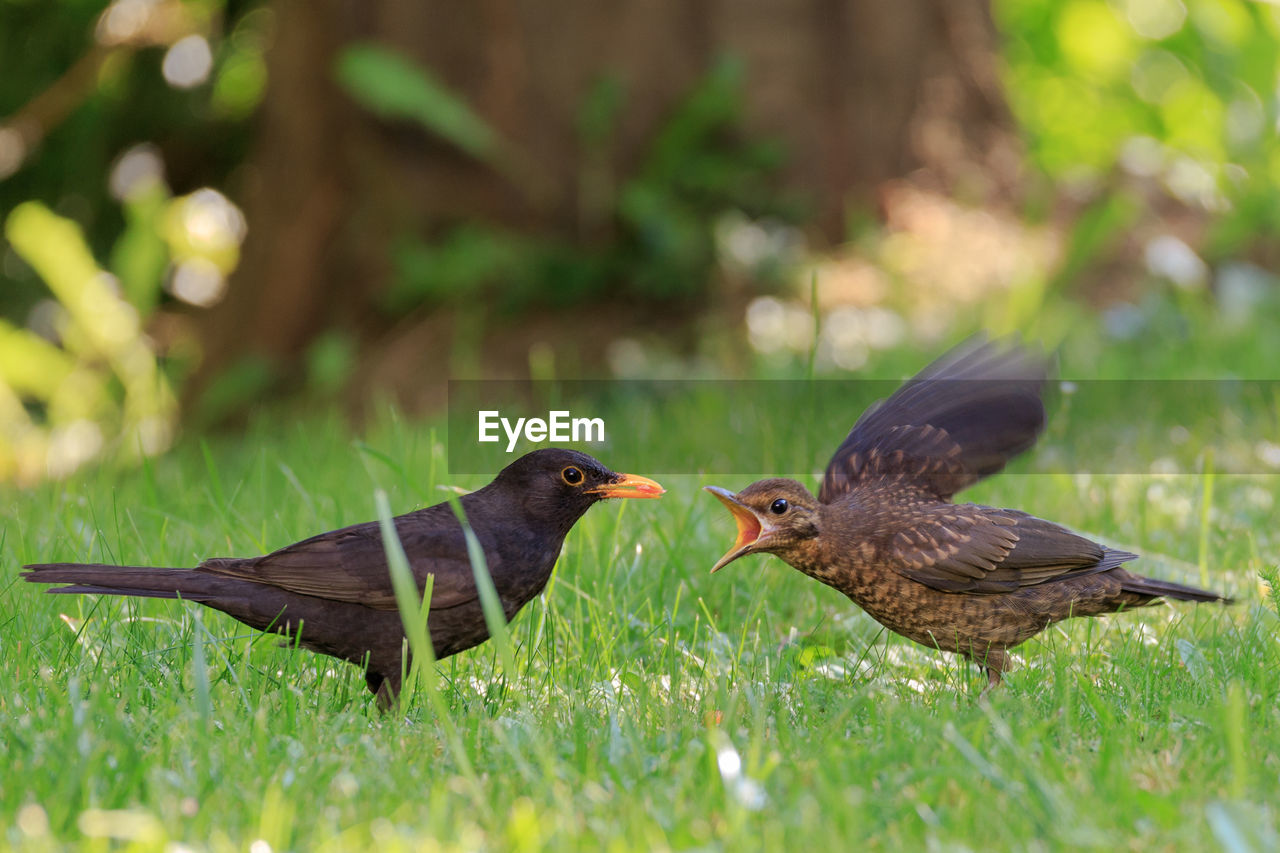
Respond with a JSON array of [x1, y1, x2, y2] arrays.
[[886, 503, 1137, 593]]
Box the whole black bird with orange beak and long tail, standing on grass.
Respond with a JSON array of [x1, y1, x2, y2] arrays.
[[23, 448, 664, 708]]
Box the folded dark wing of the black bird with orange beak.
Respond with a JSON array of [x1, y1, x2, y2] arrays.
[[200, 507, 481, 610]]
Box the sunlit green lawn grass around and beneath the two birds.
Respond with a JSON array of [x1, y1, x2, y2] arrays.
[[0, 366, 1280, 850]]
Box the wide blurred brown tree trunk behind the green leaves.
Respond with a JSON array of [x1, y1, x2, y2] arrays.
[[193, 0, 1018, 409]]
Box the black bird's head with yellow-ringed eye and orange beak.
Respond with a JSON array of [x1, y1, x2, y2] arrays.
[[493, 447, 666, 529]]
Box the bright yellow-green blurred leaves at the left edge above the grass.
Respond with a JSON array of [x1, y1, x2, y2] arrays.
[[0, 175, 249, 482]]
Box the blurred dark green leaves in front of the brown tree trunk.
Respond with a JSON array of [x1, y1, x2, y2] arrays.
[[335, 51, 800, 314]]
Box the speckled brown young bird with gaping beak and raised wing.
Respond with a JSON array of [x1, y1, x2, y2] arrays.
[[707, 339, 1228, 692]]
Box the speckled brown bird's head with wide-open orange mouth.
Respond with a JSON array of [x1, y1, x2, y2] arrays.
[[705, 479, 819, 571]]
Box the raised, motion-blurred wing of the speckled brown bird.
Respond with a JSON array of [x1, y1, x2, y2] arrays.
[[818, 338, 1048, 503]]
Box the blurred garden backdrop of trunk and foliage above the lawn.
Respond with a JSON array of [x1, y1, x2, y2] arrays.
[[0, 0, 1280, 483]]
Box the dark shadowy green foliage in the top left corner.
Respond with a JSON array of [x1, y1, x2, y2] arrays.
[[0, 0, 273, 323]]
